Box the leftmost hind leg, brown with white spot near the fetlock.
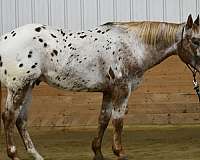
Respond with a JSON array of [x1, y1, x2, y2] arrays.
[[2, 87, 27, 160]]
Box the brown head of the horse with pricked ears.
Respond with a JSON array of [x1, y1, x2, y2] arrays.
[[177, 15, 200, 71]]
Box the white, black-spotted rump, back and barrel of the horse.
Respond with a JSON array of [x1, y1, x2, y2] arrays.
[[0, 24, 143, 91]]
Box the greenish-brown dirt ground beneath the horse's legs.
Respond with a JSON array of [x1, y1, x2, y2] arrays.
[[0, 125, 200, 160]]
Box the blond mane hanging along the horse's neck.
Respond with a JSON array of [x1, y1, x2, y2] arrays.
[[105, 21, 182, 46]]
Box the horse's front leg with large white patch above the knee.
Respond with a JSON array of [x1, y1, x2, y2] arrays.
[[112, 84, 131, 160]]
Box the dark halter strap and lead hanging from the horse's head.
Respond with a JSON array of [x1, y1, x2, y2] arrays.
[[181, 26, 200, 102]]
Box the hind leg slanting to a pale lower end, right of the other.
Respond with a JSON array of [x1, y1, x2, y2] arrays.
[[16, 86, 43, 160]]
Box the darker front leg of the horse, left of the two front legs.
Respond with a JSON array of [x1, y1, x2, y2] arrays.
[[92, 92, 112, 160]]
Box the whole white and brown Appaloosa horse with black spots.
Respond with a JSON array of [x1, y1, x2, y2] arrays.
[[0, 15, 200, 160]]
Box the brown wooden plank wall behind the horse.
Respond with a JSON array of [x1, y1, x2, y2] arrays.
[[0, 56, 200, 127]]
